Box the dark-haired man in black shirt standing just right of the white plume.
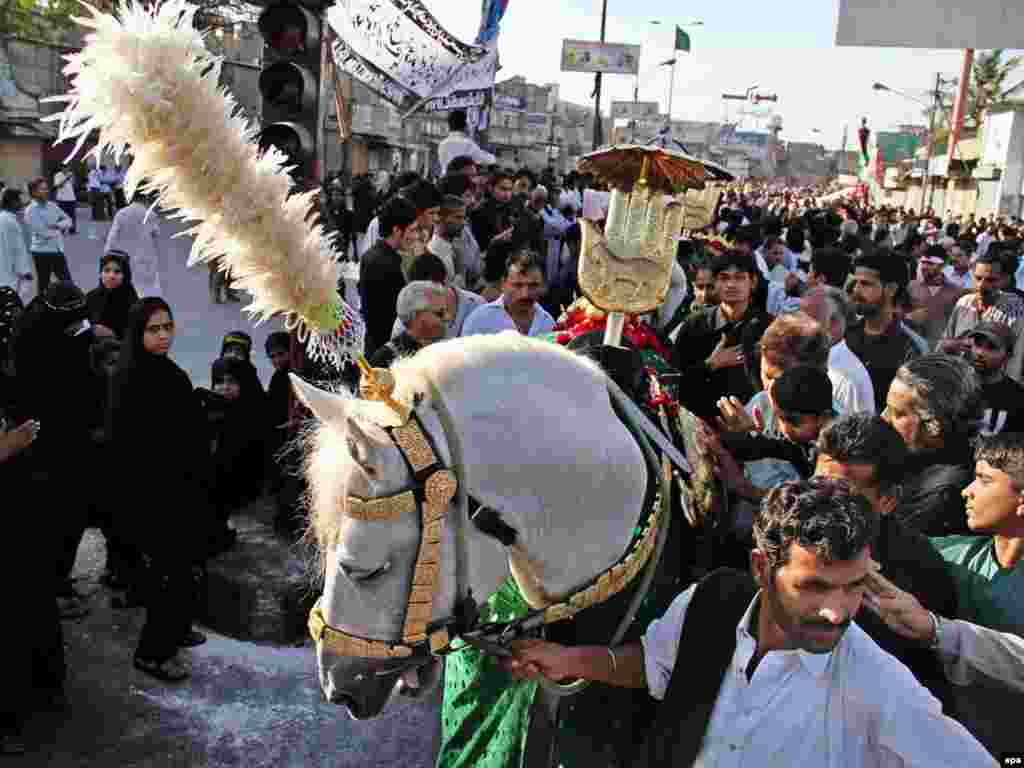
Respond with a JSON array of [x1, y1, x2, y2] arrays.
[[359, 196, 417, 354]]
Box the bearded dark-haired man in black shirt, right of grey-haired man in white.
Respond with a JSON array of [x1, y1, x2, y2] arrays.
[[846, 248, 920, 410]]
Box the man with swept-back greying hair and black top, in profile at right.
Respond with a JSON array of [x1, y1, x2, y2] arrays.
[[882, 354, 982, 536]]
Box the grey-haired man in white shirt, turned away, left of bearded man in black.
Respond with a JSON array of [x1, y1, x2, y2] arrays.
[[800, 286, 876, 414]]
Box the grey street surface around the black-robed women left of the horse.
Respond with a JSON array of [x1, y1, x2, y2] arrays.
[[11, 208, 440, 768]]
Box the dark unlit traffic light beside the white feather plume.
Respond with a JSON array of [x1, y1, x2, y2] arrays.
[[257, 0, 322, 184]]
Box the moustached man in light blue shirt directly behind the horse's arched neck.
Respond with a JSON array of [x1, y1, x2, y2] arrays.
[[462, 250, 555, 336]]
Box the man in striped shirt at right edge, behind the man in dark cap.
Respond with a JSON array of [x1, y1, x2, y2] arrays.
[[937, 253, 1024, 381]]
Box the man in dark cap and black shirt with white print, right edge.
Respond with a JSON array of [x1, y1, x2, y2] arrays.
[[966, 323, 1024, 435]]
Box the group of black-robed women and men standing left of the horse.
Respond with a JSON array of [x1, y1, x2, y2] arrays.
[[0, 169, 303, 755]]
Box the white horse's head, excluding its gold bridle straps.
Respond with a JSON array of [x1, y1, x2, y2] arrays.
[[292, 376, 455, 719]]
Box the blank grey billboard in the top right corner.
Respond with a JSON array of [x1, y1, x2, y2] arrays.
[[836, 0, 1024, 50]]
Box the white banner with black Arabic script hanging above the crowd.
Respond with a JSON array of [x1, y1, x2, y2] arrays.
[[327, 0, 498, 112]]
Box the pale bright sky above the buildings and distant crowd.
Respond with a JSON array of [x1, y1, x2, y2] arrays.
[[425, 0, 1015, 148]]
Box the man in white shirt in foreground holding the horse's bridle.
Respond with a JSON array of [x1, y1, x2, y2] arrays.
[[505, 477, 996, 768]]
